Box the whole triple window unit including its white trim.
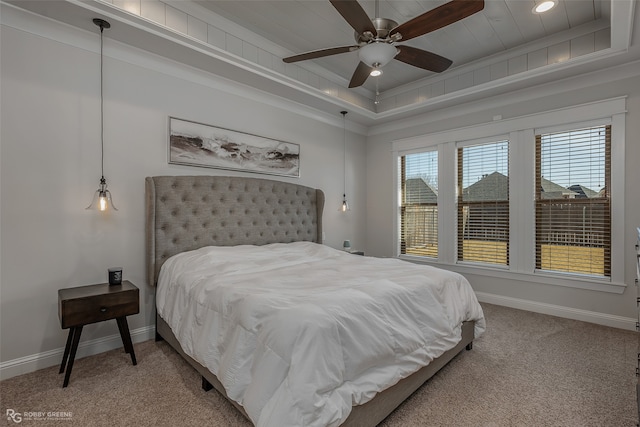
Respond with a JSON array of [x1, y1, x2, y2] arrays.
[[392, 97, 627, 293]]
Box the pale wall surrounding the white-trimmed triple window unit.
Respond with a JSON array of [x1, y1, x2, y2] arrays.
[[366, 63, 640, 328]]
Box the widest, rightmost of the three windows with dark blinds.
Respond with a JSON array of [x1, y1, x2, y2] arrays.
[[536, 126, 611, 277]]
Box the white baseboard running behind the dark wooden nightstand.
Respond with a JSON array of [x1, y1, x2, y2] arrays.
[[0, 325, 156, 380]]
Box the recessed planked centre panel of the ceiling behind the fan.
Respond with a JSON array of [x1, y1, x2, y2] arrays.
[[197, 0, 610, 92]]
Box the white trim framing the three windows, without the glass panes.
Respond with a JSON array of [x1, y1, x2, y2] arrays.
[[392, 97, 627, 294]]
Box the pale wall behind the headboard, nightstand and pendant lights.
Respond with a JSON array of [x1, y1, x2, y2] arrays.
[[0, 9, 365, 377]]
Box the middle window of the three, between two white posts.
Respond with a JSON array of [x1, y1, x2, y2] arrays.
[[457, 141, 509, 265]]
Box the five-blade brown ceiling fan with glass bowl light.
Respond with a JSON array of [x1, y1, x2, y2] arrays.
[[283, 0, 484, 88]]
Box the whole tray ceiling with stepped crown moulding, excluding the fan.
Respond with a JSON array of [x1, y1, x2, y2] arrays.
[[3, 0, 640, 127]]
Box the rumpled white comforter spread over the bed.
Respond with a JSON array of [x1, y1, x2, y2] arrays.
[[156, 242, 485, 427]]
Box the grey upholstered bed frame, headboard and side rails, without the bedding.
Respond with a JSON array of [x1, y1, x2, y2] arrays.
[[145, 176, 474, 426]]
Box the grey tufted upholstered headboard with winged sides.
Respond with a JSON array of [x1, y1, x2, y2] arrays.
[[145, 175, 324, 286]]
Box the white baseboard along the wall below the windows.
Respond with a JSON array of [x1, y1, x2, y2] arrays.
[[476, 292, 636, 331]]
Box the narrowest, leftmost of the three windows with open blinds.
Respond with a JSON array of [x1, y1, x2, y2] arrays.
[[399, 151, 438, 258]]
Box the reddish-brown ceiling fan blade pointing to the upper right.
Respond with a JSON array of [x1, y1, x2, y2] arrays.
[[389, 0, 484, 41]]
